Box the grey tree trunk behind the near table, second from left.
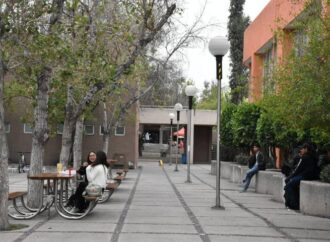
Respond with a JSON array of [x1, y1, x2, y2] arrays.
[[28, 67, 52, 208]]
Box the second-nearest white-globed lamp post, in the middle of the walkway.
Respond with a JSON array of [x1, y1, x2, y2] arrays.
[[185, 85, 197, 183]]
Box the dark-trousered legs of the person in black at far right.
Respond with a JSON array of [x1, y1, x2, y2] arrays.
[[284, 176, 302, 210]]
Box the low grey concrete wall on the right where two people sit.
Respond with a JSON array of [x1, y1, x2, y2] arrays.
[[217, 162, 330, 218]]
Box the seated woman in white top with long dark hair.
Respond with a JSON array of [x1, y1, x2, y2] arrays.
[[71, 151, 108, 213]]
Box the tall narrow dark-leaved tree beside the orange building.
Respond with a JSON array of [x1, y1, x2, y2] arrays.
[[227, 0, 250, 104]]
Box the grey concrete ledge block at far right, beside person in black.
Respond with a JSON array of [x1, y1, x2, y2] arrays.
[[300, 181, 330, 218]]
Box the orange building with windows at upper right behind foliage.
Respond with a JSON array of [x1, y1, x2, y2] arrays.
[[243, 0, 330, 168]]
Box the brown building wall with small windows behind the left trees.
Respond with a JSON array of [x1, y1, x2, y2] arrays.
[[5, 101, 139, 166]]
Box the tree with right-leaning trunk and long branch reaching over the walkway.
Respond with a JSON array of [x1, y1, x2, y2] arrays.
[[60, 0, 176, 165]]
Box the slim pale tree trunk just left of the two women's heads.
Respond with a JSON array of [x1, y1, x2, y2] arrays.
[[73, 118, 84, 169]]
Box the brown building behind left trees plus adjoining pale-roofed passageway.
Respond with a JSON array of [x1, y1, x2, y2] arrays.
[[5, 105, 216, 165]]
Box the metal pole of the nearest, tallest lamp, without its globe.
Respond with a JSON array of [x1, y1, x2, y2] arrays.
[[214, 56, 224, 209]]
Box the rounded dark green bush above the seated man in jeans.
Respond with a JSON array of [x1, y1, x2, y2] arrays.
[[231, 103, 261, 148]]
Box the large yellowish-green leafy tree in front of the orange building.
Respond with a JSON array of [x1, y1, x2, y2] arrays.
[[258, 1, 330, 148]]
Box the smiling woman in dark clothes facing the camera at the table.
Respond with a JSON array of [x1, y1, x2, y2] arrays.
[[66, 151, 96, 210]]
